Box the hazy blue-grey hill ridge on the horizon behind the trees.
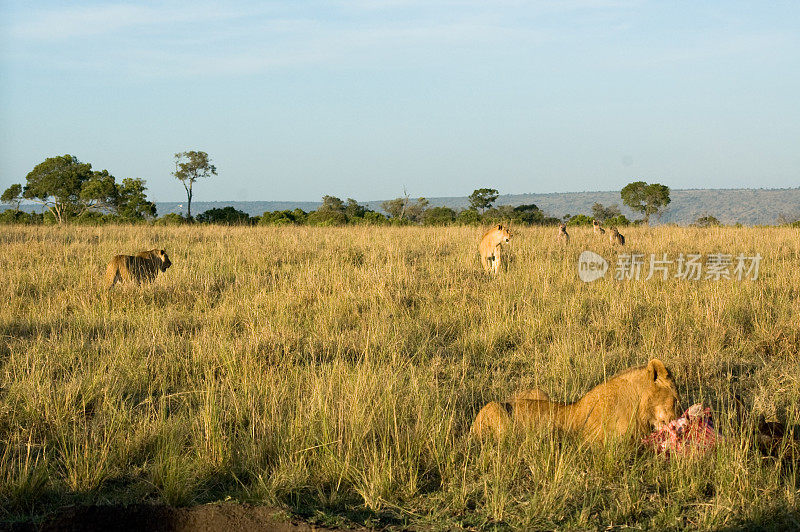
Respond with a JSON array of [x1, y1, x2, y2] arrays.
[[156, 188, 800, 225]]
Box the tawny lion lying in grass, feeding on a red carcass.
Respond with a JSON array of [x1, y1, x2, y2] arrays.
[[471, 359, 678, 443]]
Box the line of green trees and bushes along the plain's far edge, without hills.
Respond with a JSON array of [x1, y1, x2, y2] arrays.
[[0, 151, 670, 226]]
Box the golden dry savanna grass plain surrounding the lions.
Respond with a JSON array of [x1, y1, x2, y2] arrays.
[[0, 226, 800, 529]]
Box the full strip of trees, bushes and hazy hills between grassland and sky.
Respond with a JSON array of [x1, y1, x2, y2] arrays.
[[0, 156, 800, 227]]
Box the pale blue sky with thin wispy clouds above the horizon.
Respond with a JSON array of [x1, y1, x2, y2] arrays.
[[0, 0, 800, 201]]
